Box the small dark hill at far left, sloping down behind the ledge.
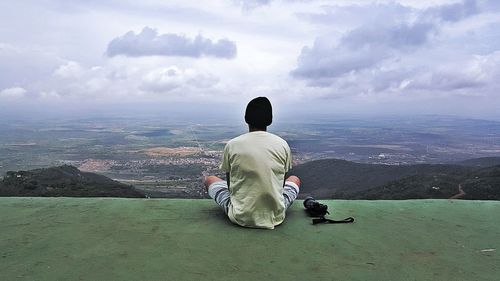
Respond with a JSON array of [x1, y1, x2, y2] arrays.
[[0, 165, 145, 198]]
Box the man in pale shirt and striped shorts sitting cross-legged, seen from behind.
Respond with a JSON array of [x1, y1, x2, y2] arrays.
[[204, 97, 300, 229]]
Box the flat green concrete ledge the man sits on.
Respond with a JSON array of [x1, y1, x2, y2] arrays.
[[0, 198, 500, 280]]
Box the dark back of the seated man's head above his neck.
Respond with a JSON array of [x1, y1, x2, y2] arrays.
[[245, 97, 273, 128]]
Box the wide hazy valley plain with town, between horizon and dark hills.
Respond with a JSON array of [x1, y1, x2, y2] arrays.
[[0, 116, 500, 198]]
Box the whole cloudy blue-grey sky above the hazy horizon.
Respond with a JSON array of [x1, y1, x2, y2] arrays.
[[0, 0, 500, 120]]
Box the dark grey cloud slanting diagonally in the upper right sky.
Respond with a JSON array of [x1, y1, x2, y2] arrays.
[[291, 23, 433, 82]]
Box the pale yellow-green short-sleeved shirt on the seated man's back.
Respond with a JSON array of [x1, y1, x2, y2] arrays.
[[221, 131, 291, 228]]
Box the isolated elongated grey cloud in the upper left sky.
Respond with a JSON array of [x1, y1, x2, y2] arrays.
[[107, 27, 237, 59]]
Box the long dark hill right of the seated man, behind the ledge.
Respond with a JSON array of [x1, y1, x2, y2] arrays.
[[291, 158, 500, 200]]
